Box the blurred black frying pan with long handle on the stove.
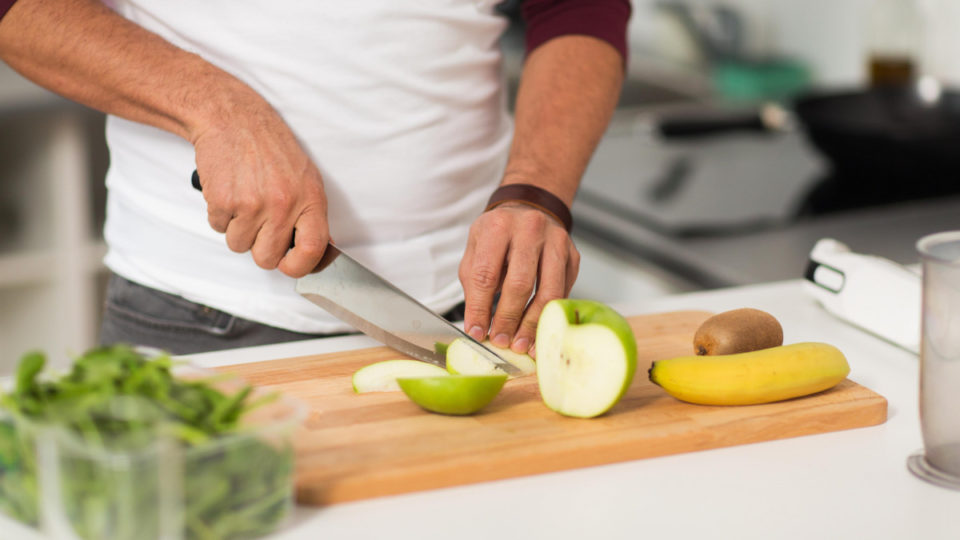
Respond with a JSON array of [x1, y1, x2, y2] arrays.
[[658, 87, 960, 213]]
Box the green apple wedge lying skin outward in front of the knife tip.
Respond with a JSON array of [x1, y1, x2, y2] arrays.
[[397, 375, 507, 415]]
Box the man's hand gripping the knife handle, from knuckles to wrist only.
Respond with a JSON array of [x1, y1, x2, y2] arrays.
[[193, 99, 330, 277]]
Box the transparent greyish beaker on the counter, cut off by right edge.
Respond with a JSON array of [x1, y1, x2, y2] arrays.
[[907, 231, 960, 489]]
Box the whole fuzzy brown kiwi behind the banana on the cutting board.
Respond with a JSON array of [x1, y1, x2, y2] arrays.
[[693, 308, 783, 356]]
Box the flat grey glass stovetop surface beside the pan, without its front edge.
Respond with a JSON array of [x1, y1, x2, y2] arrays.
[[578, 113, 825, 237]]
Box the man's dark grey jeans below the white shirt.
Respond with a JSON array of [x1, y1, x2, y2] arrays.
[[100, 274, 463, 354]]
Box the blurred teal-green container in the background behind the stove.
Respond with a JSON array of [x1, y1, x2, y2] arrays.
[[711, 58, 811, 102]]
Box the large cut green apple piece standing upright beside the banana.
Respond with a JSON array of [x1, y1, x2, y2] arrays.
[[536, 299, 637, 418]]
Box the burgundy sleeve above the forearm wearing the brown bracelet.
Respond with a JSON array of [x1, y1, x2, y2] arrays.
[[520, 0, 630, 62]]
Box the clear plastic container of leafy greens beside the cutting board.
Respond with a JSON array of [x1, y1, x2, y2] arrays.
[[0, 345, 294, 540]]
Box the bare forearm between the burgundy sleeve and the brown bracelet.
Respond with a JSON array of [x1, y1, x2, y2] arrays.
[[503, 35, 623, 206]]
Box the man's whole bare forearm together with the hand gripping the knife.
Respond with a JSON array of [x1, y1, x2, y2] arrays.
[[0, 0, 329, 277]]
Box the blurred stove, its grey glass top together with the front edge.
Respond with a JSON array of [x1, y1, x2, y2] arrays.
[[573, 112, 960, 288]]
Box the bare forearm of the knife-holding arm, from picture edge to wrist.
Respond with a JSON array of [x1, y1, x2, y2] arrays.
[[0, 0, 263, 142]]
